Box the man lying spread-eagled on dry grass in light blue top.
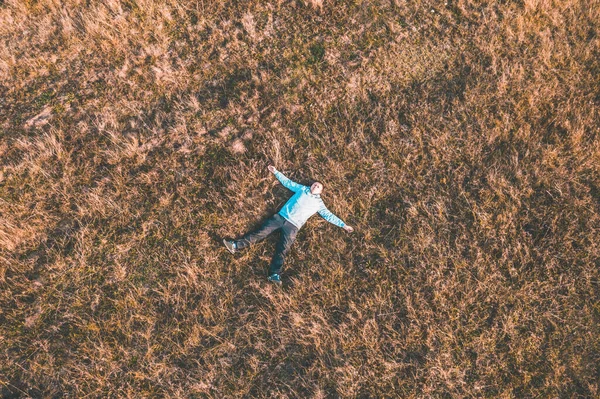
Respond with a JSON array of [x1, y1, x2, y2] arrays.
[[223, 165, 354, 284]]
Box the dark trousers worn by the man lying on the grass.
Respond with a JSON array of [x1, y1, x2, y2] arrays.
[[234, 213, 298, 275]]
